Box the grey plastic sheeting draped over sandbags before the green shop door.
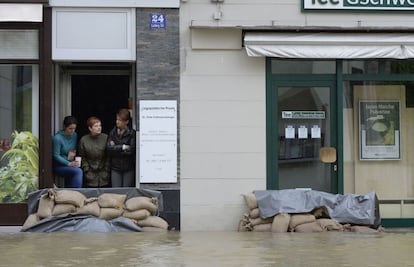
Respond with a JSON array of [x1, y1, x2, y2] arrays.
[[254, 189, 381, 228]]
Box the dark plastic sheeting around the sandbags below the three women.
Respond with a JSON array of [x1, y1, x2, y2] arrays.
[[21, 188, 163, 233]]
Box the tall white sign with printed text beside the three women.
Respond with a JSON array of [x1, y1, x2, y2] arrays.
[[139, 100, 177, 183]]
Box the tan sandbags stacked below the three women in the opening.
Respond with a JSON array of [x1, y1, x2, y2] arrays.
[[22, 189, 168, 232]]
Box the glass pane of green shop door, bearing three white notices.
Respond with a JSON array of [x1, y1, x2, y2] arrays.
[[278, 87, 331, 192]]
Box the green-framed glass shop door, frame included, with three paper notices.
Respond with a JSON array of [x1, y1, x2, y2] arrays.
[[267, 66, 338, 193]]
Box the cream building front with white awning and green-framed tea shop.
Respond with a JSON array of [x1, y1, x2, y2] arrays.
[[180, 0, 414, 230]]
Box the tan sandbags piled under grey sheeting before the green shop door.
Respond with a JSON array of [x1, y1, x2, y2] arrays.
[[239, 193, 354, 233]]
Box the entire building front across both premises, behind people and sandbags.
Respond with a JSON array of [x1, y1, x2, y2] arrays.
[[0, 0, 414, 231]]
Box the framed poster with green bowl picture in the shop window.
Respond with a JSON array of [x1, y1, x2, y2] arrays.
[[359, 100, 400, 160]]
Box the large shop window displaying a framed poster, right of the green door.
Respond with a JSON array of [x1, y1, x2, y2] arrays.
[[343, 81, 414, 218]]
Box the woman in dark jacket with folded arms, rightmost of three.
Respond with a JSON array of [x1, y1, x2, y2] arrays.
[[106, 109, 136, 187]]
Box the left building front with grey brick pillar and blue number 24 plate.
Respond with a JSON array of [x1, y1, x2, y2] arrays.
[[0, 0, 180, 229]]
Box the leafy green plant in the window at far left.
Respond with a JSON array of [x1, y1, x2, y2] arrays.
[[0, 131, 39, 202]]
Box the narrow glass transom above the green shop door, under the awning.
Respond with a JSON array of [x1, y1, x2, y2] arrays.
[[271, 59, 336, 74]]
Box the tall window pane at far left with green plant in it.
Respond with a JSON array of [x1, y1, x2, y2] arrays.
[[0, 65, 39, 203]]
